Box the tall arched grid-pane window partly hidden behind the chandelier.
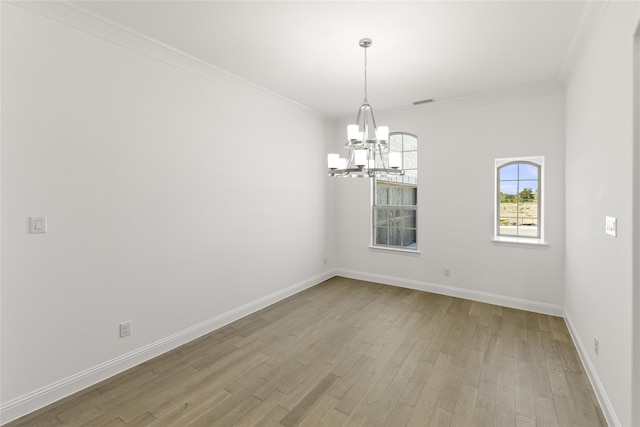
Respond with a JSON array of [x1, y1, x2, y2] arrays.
[[371, 132, 418, 250]]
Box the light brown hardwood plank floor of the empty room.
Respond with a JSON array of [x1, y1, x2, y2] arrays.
[[8, 277, 606, 427]]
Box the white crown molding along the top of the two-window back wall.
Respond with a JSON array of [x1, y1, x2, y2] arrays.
[[364, 80, 565, 120]]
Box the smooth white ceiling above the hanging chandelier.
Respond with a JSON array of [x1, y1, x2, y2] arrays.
[[69, 0, 586, 117]]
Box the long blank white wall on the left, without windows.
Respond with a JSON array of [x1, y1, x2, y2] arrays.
[[0, 2, 334, 422]]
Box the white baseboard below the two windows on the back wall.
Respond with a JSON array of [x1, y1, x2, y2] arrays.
[[335, 268, 564, 317]]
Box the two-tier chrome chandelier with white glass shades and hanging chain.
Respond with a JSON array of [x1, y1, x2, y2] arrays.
[[327, 39, 404, 177]]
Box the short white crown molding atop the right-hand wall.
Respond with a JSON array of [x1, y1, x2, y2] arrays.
[[558, 0, 609, 88]]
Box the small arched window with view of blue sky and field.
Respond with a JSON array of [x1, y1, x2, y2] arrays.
[[496, 157, 544, 240]]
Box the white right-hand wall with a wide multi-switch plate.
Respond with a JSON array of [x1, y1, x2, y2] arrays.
[[565, 2, 640, 426]]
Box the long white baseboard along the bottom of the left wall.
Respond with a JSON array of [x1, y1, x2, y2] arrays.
[[0, 270, 335, 425]]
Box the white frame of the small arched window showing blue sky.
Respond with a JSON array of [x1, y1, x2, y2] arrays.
[[493, 156, 547, 245]]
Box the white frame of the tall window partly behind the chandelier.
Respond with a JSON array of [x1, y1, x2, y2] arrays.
[[369, 131, 420, 254]]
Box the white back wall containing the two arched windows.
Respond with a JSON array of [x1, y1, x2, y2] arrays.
[[336, 87, 564, 314]]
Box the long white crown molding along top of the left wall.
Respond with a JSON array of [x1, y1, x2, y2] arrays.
[[3, 0, 333, 125]]
